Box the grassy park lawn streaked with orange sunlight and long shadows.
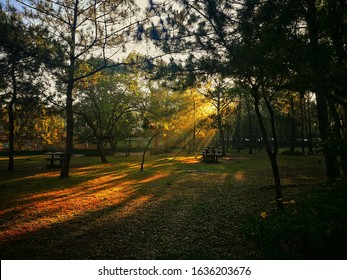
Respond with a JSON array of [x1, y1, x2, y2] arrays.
[[0, 152, 347, 259]]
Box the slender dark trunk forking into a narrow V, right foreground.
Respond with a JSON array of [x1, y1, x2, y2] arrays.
[[253, 92, 284, 210]]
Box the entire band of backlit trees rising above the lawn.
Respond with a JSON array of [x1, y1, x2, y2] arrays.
[[0, 0, 347, 208]]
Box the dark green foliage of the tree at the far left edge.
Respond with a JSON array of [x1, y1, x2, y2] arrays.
[[0, 3, 49, 94]]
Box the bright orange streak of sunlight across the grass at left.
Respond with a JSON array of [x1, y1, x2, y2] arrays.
[[0, 172, 170, 242]]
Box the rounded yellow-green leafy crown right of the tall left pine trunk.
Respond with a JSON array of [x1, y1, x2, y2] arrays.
[[75, 59, 143, 160]]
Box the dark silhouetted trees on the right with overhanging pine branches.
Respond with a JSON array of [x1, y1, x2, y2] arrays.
[[149, 0, 347, 208]]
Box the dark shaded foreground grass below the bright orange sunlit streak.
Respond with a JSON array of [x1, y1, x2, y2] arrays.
[[1, 165, 256, 259]]
